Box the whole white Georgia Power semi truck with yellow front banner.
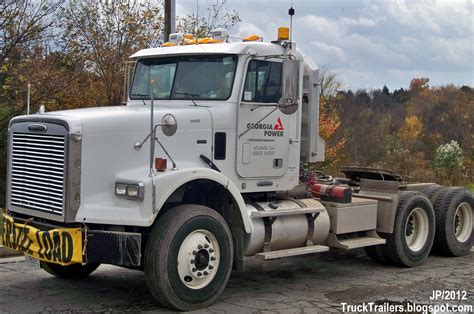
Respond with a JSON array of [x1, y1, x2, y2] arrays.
[[3, 29, 474, 310]]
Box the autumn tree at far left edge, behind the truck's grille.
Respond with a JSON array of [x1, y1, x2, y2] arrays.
[[0, 0, 61, 206]]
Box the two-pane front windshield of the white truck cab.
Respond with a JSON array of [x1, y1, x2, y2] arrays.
[[130, 55, 237, 100]]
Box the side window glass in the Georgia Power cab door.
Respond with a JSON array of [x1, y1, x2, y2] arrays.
[[242, 60, 282, 103]]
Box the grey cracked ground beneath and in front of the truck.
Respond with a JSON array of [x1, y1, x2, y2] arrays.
[[0, 250, 474, 313]]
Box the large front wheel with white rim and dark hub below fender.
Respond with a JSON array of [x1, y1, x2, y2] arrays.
[[145, 205, 234, 311]]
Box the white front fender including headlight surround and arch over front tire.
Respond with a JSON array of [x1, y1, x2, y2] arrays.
[[76, 163, 252, 229]]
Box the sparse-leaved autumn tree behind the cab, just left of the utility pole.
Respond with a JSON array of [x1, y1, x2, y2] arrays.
[[60, 0, 163, 105]]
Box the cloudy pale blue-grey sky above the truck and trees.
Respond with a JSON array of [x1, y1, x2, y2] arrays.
[[176, 0, 474, 91]]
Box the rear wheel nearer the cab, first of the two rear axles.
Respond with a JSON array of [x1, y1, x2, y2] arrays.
[[382, 191, 435, 267]]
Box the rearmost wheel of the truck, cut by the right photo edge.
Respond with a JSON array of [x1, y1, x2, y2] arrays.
[[434, 187, 474, 256]]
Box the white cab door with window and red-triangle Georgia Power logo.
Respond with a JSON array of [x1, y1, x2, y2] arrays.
[[237, 59, 291, 178]]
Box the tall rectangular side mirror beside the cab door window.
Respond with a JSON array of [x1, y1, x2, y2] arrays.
[[278, 60, 300, 114]]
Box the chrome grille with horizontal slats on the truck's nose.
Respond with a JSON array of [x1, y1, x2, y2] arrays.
[[11, 133, 65, 215]]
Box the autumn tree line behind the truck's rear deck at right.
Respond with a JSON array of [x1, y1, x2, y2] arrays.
[[321, 78, 474, 184]]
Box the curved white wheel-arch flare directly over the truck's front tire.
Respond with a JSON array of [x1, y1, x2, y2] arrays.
[[154, 167, 252, 233]]
